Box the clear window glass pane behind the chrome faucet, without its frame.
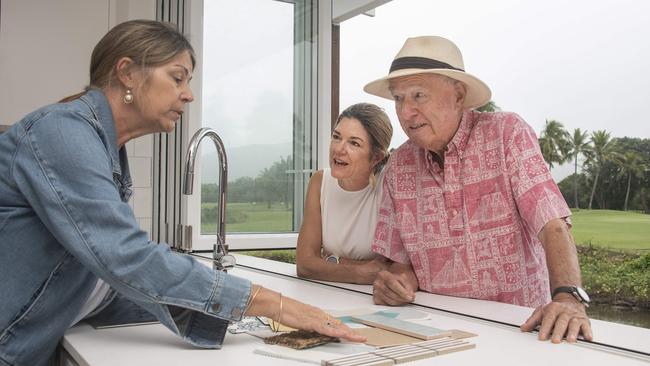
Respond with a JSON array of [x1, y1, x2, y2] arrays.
[[201, 0, 311, 234]]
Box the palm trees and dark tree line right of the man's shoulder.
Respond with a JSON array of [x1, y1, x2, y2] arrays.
[[539, 120, 650, 213]]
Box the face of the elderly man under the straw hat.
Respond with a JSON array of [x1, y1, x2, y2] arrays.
[[389, 74, 465, 156]]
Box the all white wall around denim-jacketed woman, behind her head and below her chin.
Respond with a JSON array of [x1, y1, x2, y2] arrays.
[[0, 0, 156, 237]]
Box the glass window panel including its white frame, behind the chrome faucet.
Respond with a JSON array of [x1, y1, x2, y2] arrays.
[[182, 0, 331, 250]]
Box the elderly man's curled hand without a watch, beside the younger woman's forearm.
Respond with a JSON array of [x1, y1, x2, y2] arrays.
[[372, 263, 418, 306]]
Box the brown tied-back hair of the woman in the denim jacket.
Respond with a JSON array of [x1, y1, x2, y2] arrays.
[[62, 19, 196, 102]]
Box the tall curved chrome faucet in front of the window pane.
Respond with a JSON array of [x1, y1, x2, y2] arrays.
[[183, 128, 236, 271]]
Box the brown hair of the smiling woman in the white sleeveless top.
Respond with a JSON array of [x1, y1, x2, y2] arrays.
[[334, 103, 393, 186]]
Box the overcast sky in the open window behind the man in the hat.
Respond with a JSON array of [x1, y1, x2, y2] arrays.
[[341, 0, 650, 150]]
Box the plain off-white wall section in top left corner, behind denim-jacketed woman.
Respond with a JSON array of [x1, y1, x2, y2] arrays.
[[0, 0, 109, 125]]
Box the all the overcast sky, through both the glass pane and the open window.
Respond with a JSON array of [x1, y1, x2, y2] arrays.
[[203, 0, 650, 179]]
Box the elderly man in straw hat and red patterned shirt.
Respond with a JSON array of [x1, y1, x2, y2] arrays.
[[364, 37, 592, 342]]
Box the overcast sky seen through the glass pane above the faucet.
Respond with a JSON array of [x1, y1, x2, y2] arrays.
[[202, 0, 293, 149]]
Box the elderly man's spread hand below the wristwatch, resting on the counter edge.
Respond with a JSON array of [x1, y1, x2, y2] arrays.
[[521, 294, 593, 343]]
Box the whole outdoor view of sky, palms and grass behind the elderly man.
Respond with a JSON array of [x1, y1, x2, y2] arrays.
[[340, 0, 650, 328]]
